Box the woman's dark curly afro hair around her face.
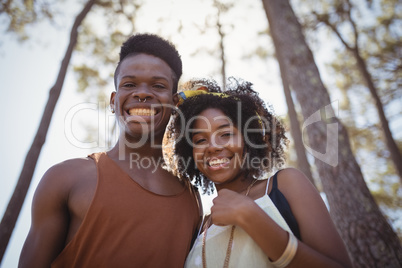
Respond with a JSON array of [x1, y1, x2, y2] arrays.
[[168, 77, 288, 193]]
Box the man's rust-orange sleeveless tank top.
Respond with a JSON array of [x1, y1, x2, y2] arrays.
[[52, 153, 199, 268]]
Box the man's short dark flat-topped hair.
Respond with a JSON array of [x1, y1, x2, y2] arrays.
[[114, 33, 183, 93]]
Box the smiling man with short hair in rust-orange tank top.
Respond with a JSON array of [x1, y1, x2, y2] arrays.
[[19, 34, 200, 268]]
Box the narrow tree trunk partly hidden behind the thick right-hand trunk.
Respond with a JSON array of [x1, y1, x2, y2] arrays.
[[277, 55, 317, 187]]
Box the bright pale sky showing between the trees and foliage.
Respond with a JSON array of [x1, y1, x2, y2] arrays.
[[0, 0, 398, 268]]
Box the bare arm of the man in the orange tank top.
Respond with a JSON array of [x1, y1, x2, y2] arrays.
[[19, 164, 70, 267]]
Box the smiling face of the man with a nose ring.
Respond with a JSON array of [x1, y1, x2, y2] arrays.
[[110, 54, 173, 139]]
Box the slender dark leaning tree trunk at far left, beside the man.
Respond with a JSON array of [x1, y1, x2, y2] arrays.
[[0, 0, 96, 262]]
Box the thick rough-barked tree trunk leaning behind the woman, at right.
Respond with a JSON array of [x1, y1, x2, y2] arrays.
[[263, 0, 402, 267]]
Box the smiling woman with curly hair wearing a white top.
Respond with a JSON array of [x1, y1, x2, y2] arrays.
[[170, 76, 351, 267]]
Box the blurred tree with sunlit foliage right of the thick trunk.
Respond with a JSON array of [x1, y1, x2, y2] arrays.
[[298, 0, 402, 238]]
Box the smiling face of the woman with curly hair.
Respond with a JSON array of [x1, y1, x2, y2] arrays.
[[191, 108, 244, 188]]
